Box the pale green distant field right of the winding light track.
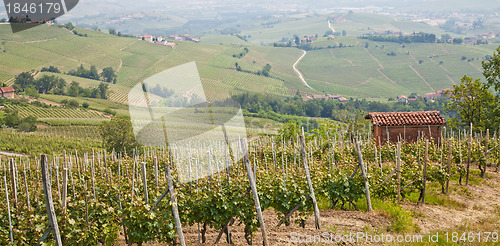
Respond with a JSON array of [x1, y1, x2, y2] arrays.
[[298, 37, 497, 97]]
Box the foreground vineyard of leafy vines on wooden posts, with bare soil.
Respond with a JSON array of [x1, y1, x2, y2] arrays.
[[0, 132, 500, 245]]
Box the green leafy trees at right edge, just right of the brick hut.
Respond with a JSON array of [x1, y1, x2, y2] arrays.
[[446, 47, 500, 130]]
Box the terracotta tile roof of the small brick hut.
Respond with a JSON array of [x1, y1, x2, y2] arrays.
[[365, 111, 446, 126]]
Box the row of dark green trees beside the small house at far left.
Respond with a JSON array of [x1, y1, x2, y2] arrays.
[[14, 71, 108, 99]]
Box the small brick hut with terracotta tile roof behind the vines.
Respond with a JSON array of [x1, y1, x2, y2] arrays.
[[365, 111, 446, 144]]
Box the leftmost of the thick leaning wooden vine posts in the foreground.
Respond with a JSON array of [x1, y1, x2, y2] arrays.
[[40, 155, 62, 246]]
